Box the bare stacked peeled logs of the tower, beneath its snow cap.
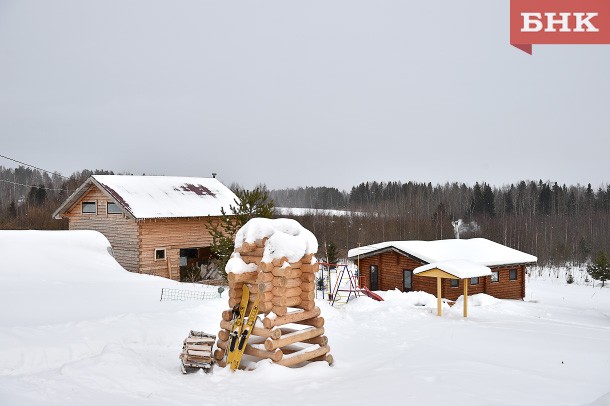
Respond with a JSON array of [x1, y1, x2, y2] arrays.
[[214, 238, 333, 366]]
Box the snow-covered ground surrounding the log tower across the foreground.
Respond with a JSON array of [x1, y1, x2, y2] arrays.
[[0, 231, 610, 406]]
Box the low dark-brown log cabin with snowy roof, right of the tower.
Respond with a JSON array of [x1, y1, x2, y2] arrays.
[[348, 238, 537, 300]]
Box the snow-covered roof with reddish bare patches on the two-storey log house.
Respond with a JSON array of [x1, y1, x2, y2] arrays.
[[78, 175, 237, 219]]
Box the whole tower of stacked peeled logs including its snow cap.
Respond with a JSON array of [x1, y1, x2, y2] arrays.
[[214, 219, 333, 368]]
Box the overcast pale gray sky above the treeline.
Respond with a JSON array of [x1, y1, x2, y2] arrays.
[[0, 0, 610, 188]]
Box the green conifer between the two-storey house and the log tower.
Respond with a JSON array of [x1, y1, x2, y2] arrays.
[[208, 186, 274, 280]]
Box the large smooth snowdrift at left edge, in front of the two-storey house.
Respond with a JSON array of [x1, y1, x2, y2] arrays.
[[0, 230, 188, 328]]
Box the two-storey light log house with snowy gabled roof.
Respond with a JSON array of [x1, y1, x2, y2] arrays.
[[53, 175, 237, 280]]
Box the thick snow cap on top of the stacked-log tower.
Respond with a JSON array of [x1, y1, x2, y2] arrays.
[[235, 218, 318, 269]]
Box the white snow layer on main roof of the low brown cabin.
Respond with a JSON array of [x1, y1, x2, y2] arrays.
[[348, 238, 538, 266]]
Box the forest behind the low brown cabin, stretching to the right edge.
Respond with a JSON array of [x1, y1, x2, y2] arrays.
[[270, 181, 610, 264]]
